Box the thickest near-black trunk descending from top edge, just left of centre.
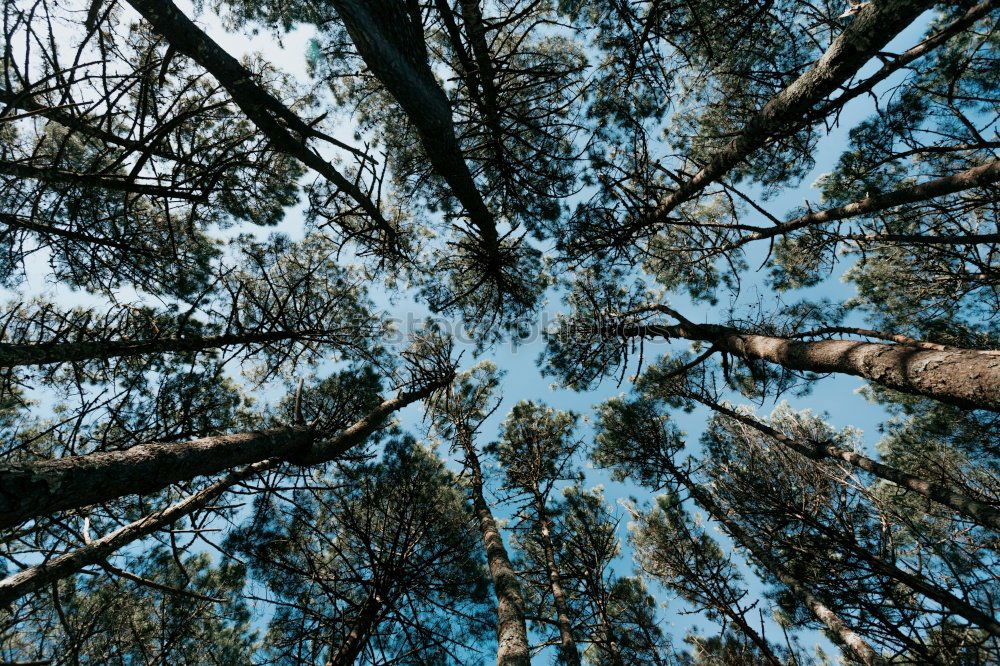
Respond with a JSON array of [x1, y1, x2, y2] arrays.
[[333, 0, 499, 255]]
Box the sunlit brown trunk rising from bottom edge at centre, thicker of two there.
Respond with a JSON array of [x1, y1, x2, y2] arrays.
[[460, 433, 531, 666]]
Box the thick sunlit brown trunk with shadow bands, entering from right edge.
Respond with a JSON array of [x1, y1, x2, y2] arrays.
[[624, 306, 1000, 412]]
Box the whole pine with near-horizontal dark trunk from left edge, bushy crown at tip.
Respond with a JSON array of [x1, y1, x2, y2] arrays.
[[0, 236, 381, 372]]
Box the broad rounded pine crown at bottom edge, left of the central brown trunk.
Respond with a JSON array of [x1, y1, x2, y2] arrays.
[[229, 439, 492, 664]]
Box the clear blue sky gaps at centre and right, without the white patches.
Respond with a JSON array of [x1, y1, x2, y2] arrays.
[[370, 17, 927, 655]]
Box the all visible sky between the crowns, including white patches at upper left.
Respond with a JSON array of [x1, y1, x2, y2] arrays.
[[6, 3, 926, 661]]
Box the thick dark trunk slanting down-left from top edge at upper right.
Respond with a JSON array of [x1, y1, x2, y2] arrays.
[[637, 0, 934, 229]]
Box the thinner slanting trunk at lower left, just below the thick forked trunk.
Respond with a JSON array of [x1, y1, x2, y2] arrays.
[[0, 460, 280, 607]]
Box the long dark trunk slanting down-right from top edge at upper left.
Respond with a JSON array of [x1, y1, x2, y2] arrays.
[[119, 0, 399, 248]]
